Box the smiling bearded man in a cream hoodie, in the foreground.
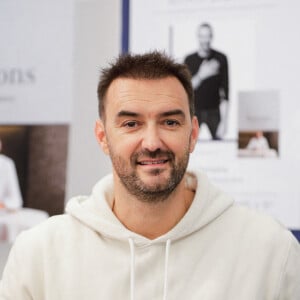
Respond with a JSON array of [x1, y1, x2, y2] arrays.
[[0, 52, 300, 300]]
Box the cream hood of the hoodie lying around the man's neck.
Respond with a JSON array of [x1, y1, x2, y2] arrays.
[[66, 172, 233, 246]]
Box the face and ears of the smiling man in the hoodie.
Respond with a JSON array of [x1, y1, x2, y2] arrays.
[[96, 77, 198, 202]]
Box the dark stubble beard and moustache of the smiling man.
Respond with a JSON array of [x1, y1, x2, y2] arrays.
[[110, 149, 189, 203]]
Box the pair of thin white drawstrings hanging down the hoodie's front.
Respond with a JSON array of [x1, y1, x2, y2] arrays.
[[128, 238, 171, 300]]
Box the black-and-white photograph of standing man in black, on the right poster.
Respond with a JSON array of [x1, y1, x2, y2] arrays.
[[169, 16, 256, 142]]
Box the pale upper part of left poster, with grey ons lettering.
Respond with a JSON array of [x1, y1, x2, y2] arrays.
[[0, 0, 73, 125]]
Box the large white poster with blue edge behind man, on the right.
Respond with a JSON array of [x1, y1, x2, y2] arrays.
[[128, 0, 300, 234]]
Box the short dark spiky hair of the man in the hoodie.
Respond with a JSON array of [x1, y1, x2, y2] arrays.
[[97, 51, 195, 119]]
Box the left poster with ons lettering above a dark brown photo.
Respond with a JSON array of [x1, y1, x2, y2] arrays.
[[0, 0, 74, 216]]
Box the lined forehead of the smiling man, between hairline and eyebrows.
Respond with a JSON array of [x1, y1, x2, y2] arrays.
[[105, 77, 189, 113]]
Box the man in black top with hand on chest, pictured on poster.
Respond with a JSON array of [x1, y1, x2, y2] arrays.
[[184, 23, 229, 140]]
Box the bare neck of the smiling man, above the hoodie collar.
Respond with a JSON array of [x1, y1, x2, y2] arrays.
[[112, 173, 194, 239]]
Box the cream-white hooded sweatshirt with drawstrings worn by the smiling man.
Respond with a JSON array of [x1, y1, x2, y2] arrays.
[[0, 174, 300, 300]]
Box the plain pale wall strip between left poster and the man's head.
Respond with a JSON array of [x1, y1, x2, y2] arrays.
[[66, 0, 122, 200]]
